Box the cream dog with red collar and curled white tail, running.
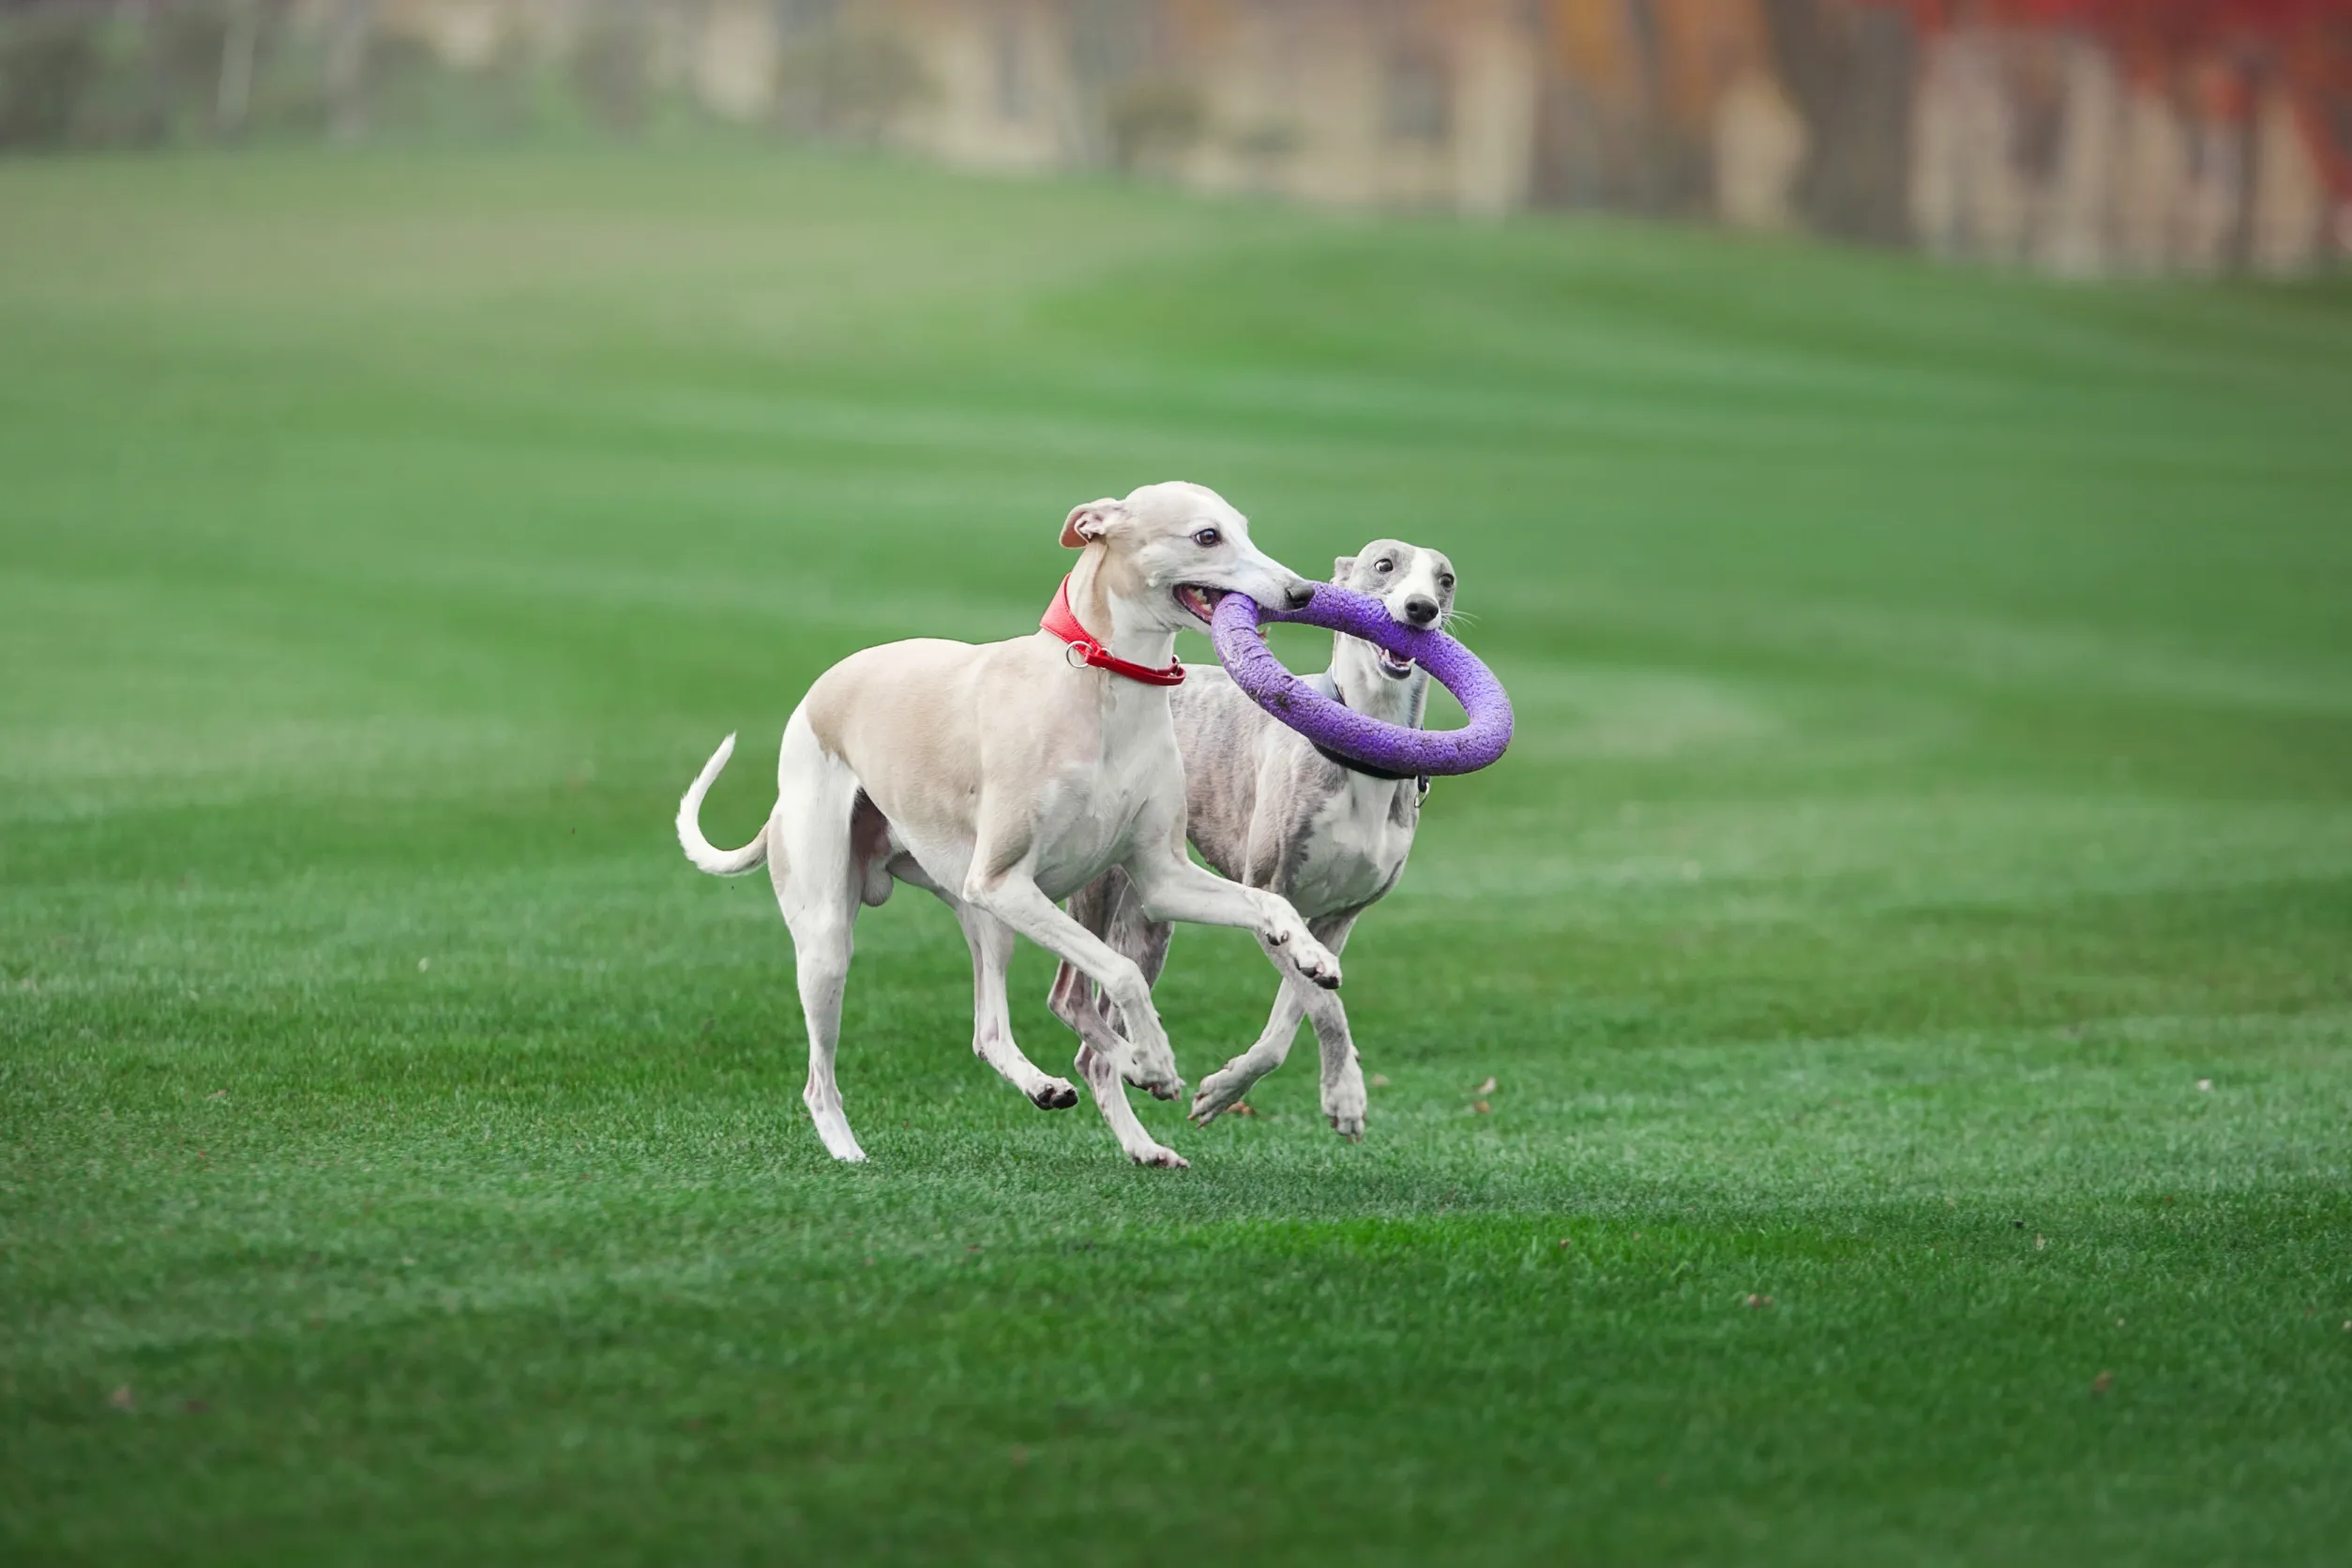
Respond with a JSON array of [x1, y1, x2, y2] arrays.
[[677, 482, 1341, 1166]]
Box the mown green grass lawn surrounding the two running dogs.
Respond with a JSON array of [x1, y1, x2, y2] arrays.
[[0, 153, 2352, 1563]]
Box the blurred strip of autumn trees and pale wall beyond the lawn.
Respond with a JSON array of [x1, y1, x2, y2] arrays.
[[13, 0, 2352, 275]]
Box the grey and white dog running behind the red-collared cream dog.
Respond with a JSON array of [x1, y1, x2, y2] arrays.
[[1051, 538, 1454, 1140]]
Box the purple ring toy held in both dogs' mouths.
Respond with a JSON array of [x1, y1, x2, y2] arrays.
[[1209, 583, 1510, 778]]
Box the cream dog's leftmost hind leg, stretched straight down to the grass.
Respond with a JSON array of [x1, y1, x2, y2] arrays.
[[767, 713, 866, 1159]]
